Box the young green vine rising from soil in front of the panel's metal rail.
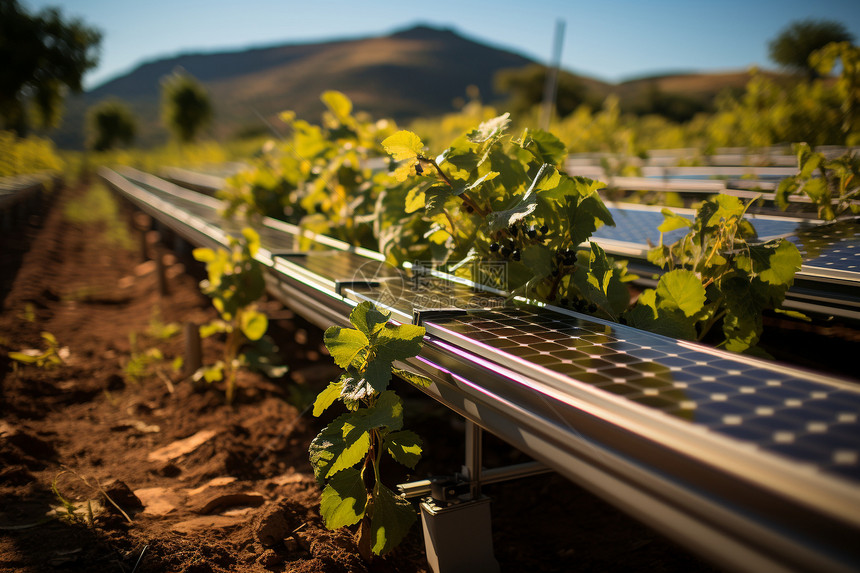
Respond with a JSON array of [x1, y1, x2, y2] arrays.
[[309, 302, 430, 560]]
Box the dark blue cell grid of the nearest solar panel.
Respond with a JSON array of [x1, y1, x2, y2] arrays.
[[425, 308, 860, 481]]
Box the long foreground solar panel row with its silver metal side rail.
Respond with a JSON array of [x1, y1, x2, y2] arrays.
[[102, 166, 860, 572]]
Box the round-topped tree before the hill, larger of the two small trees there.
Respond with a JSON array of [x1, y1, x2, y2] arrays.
[[161, 70, 213, 143]]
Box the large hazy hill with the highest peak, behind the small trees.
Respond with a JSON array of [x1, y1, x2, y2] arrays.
[[53, 26, 532, 148]]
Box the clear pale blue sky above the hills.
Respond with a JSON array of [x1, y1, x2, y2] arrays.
[[19, 0, 860, 88]]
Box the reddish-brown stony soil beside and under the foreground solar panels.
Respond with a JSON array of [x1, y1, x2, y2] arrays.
[[0, 185, 711, 573]]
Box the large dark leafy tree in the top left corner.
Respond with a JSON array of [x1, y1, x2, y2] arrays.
[[0, 0, 101, 136]]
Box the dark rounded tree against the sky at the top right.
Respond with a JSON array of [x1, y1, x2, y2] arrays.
[[768, 20, 854, 80]]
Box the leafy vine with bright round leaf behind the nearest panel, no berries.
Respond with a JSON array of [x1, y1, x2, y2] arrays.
[[623, 195, 805, 353]]
